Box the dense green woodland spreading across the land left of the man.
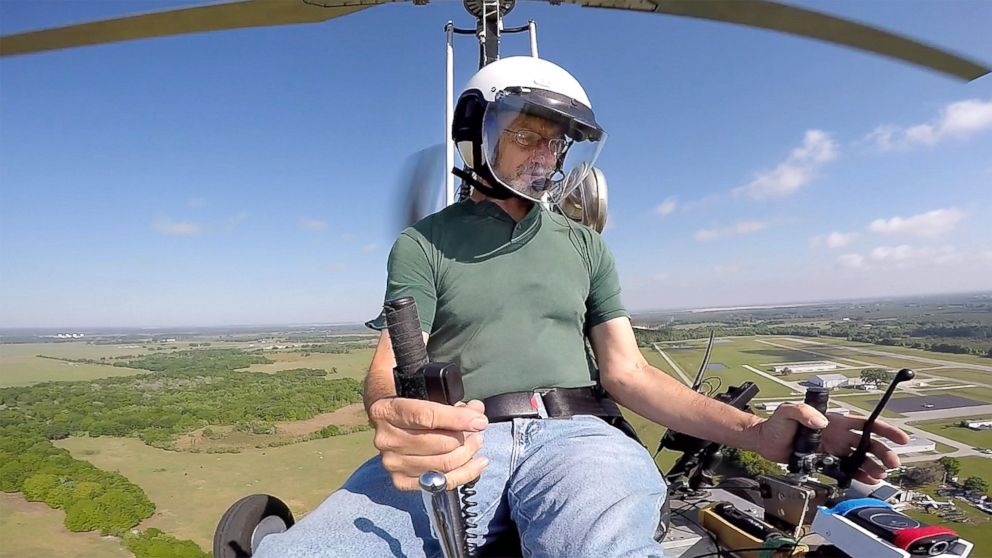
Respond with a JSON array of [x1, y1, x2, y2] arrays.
[[0, 349, 362, 558]]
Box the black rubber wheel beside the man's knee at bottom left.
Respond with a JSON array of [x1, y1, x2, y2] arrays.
[[214, 494, 295, 558]]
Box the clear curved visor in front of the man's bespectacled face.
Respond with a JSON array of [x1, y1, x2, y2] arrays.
[[482, 90, 606, 204]]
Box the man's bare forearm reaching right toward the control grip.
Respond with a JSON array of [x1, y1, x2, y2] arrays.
[[603, 363, 763, 450]]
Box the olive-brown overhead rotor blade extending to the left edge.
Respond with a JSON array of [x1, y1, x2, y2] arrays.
[[0, 0, 390, 56]]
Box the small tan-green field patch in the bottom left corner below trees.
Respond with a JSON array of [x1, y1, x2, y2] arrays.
[[0, 492, 133, 558]]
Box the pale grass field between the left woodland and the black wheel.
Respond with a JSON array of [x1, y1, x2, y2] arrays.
[[52, 432, 375, 556]]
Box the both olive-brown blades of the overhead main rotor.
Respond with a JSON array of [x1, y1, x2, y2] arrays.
[[0, 0, 990, 80]]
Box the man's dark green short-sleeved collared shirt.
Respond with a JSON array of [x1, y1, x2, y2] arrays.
[[369, 200, 629, 400]]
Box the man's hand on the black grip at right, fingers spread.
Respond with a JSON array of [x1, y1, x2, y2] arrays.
[[754, 403, 909, 484]]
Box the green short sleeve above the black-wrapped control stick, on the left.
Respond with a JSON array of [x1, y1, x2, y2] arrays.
[[365, 229, 437, 333]]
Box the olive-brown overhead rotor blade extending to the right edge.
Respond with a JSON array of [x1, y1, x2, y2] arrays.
[[564, 0, 992, 81]]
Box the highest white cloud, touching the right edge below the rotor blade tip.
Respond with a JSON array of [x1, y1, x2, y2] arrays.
[[865, 99, 992, 151]]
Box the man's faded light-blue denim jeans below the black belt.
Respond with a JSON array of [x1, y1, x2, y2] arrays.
[[255, 416, 666, 558]]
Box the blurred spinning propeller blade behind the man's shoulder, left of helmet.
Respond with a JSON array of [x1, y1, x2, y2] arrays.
[[391, 144, 445, 233]]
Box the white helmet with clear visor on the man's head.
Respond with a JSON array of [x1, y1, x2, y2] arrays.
[[451, 56, 606, 203]]
